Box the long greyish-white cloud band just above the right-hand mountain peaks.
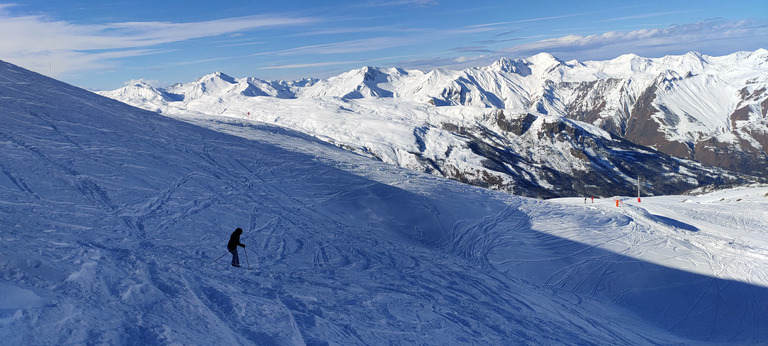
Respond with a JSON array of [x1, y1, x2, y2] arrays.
[[398, 20, 768, 70]]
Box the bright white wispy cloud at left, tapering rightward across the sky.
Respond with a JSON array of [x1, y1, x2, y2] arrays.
[[0, 5, 317, 75]]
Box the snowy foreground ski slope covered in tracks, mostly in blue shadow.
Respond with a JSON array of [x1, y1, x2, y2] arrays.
[[0, 58, 768, 345]]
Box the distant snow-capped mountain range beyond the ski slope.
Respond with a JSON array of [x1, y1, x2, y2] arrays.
[[101, 49, 768, 197]]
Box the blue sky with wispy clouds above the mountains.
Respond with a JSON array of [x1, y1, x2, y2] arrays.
[[0, 0, 768, 89]]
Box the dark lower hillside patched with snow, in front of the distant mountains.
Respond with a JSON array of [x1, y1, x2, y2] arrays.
[[432, 111, 759, 198]]
